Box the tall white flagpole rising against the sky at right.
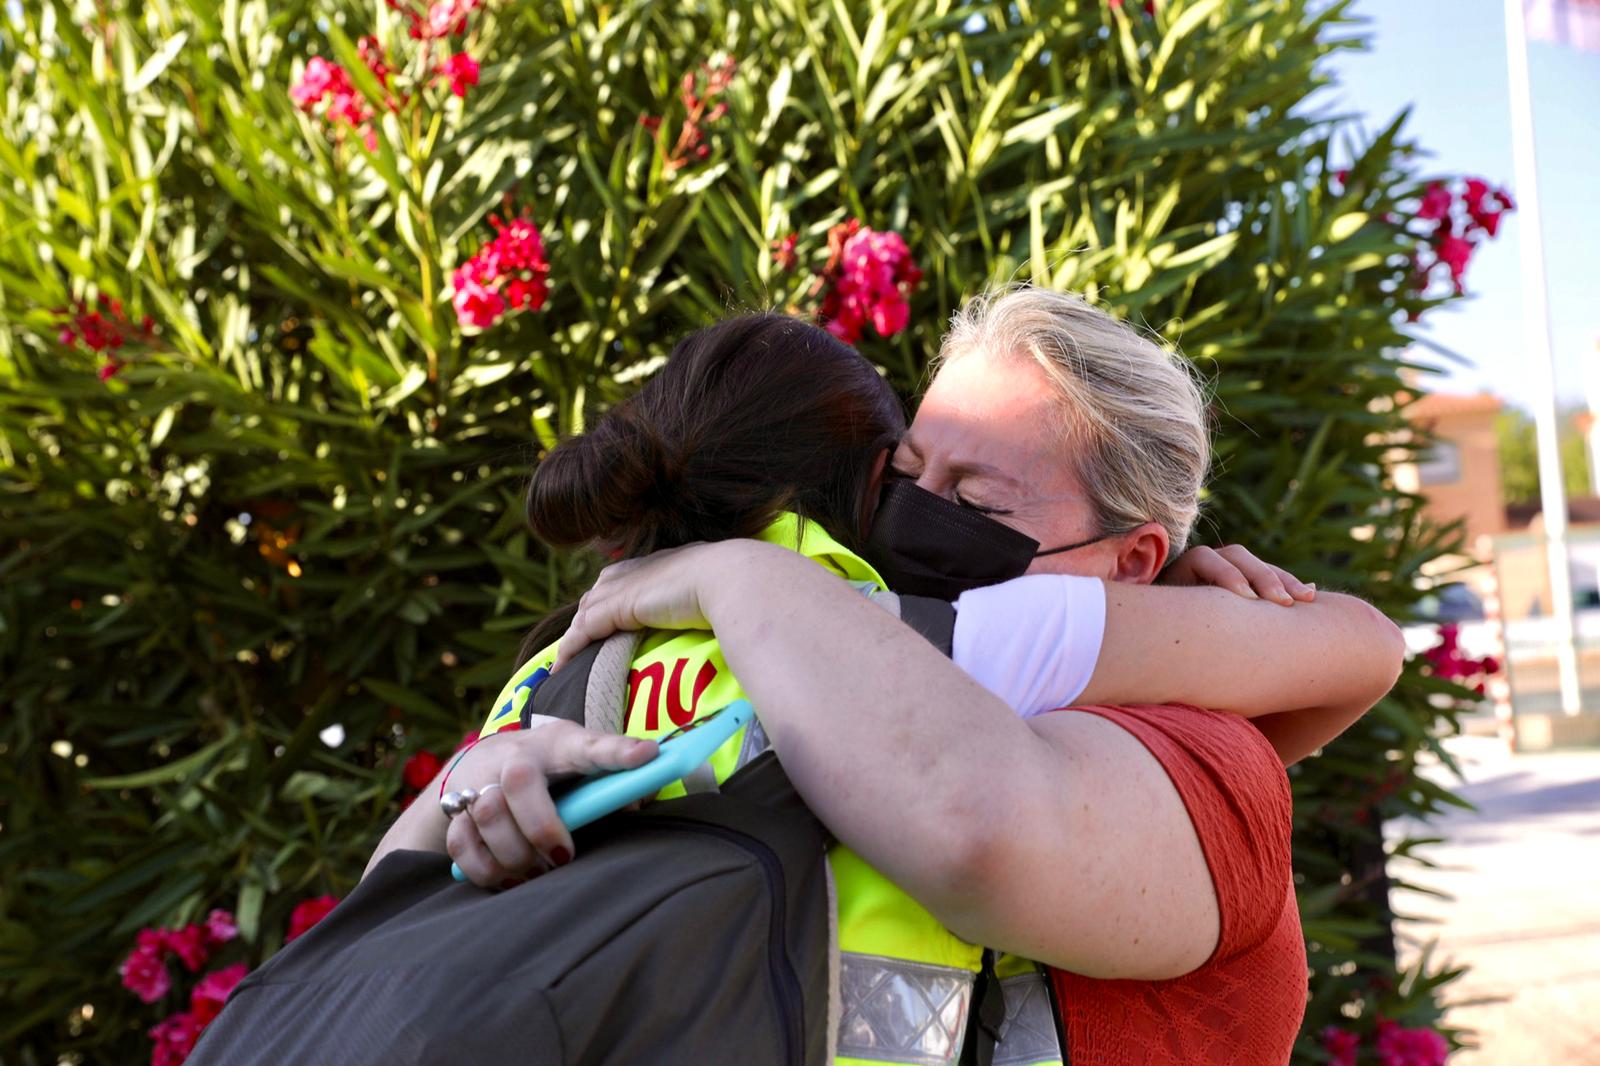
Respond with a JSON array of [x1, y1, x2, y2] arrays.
[[1506, 0, 1582, 714]]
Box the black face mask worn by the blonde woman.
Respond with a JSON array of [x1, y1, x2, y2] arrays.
[[862, 477, 1110, 600]]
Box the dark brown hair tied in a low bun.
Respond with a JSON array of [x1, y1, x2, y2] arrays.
[[518, 314, 906, 663]]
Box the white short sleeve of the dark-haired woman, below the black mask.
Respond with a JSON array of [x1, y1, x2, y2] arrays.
[[950, 573, 1106, 719]]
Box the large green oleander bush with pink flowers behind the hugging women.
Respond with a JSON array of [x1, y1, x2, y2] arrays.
[[0, 0, 1509, 1064]]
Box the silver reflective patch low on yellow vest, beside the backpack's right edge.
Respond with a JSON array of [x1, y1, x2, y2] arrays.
[[837, 951, 976, 1066]]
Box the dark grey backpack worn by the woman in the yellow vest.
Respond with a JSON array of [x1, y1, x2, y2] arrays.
[[189, 599, 1049, 1066]]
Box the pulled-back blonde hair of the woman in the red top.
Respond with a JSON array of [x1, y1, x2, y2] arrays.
[[936, 285, 1211, 555]]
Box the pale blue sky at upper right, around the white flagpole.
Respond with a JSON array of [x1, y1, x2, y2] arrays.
[[1330, 0, 1600, 408]]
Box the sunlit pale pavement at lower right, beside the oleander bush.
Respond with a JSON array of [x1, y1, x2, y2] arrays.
[[1390, 738, 1600, 1066]]
